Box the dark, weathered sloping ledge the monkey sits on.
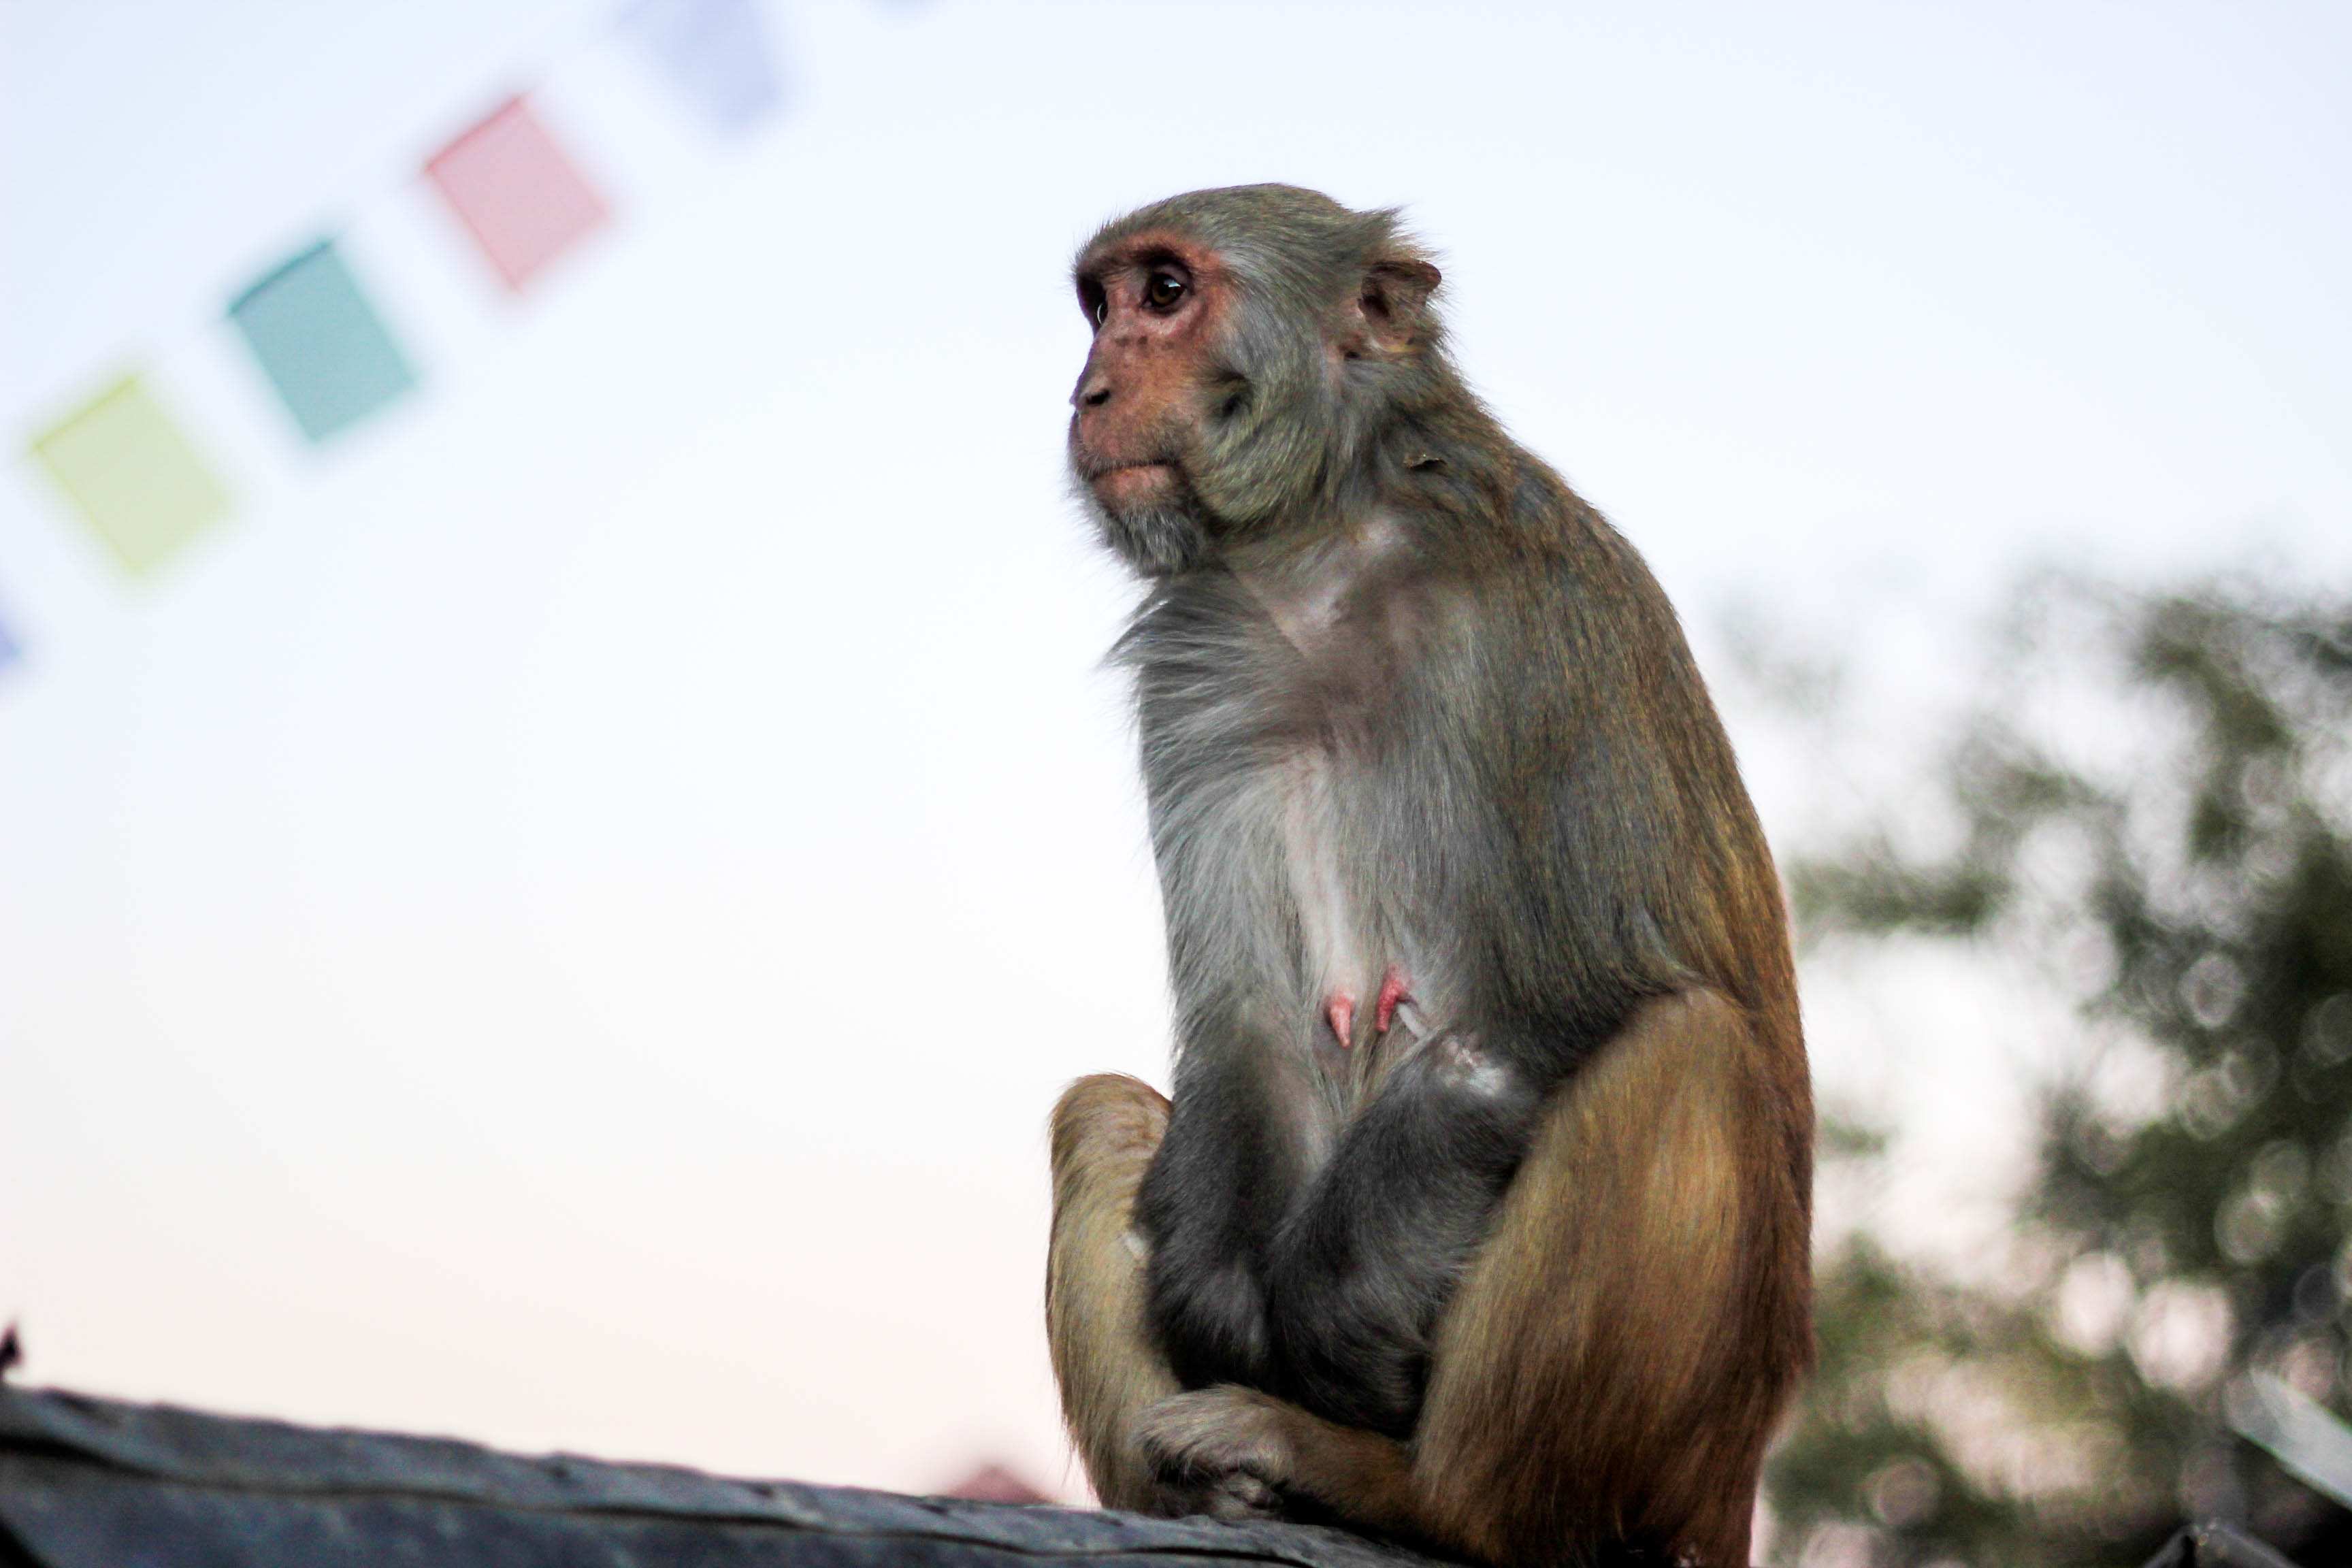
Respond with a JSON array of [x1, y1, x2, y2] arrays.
[[0, 1387, 1428, 1568]]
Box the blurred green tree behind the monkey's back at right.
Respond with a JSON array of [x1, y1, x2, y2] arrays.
[[1769, 578, 2352, 1568]]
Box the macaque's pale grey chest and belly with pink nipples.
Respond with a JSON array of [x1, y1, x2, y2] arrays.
[[1136, 561, 1444, 1081]]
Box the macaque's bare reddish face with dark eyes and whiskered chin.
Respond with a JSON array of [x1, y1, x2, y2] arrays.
[[1070, 233, 1232, 576]]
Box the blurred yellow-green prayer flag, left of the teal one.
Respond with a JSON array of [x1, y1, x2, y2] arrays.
[[33, 376, 228, 574]]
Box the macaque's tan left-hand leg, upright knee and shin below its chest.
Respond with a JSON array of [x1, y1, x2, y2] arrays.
[[1044, 1072, 1176, 1512]]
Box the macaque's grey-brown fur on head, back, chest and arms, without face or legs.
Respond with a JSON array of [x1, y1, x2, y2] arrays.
[[1073, 186, 1804, 1437]]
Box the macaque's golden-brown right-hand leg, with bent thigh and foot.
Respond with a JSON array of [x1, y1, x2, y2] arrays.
[[1136, 992, 1809, 1568]]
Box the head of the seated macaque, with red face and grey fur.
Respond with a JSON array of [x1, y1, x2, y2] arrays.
[[1070, 186, 1454, 576]]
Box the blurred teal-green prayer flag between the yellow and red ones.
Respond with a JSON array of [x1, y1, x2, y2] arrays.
[[228, 240, 416, 442]]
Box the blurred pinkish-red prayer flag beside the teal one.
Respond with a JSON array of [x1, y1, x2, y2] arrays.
[[426, 99, 609, 289]]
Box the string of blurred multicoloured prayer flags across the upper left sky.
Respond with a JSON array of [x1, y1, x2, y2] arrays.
[[0, 0, 783, 668]]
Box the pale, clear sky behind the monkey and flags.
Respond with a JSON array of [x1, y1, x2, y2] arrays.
[[0, 0, 2352, 1492]]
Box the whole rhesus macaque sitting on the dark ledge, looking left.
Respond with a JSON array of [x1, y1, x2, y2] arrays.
[[1047, 186, 1814, 1568]]
